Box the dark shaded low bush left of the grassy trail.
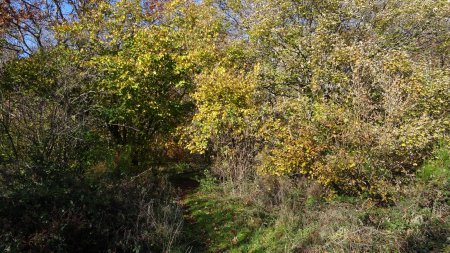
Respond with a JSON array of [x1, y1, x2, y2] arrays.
[[0, 170, 183, 252]]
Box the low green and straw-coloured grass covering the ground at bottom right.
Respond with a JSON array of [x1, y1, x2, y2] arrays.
[[184, 186, 450, 252]]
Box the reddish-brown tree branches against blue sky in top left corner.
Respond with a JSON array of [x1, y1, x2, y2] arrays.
[[0, 0, 102, 56]]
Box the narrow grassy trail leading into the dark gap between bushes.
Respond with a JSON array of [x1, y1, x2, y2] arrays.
[[170, 173, 264, 252]]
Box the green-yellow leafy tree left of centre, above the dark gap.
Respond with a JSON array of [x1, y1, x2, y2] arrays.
[[59, 1, 198, 168]]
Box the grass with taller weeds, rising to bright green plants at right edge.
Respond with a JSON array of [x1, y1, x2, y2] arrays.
[[176, 145, 450, 252]]
